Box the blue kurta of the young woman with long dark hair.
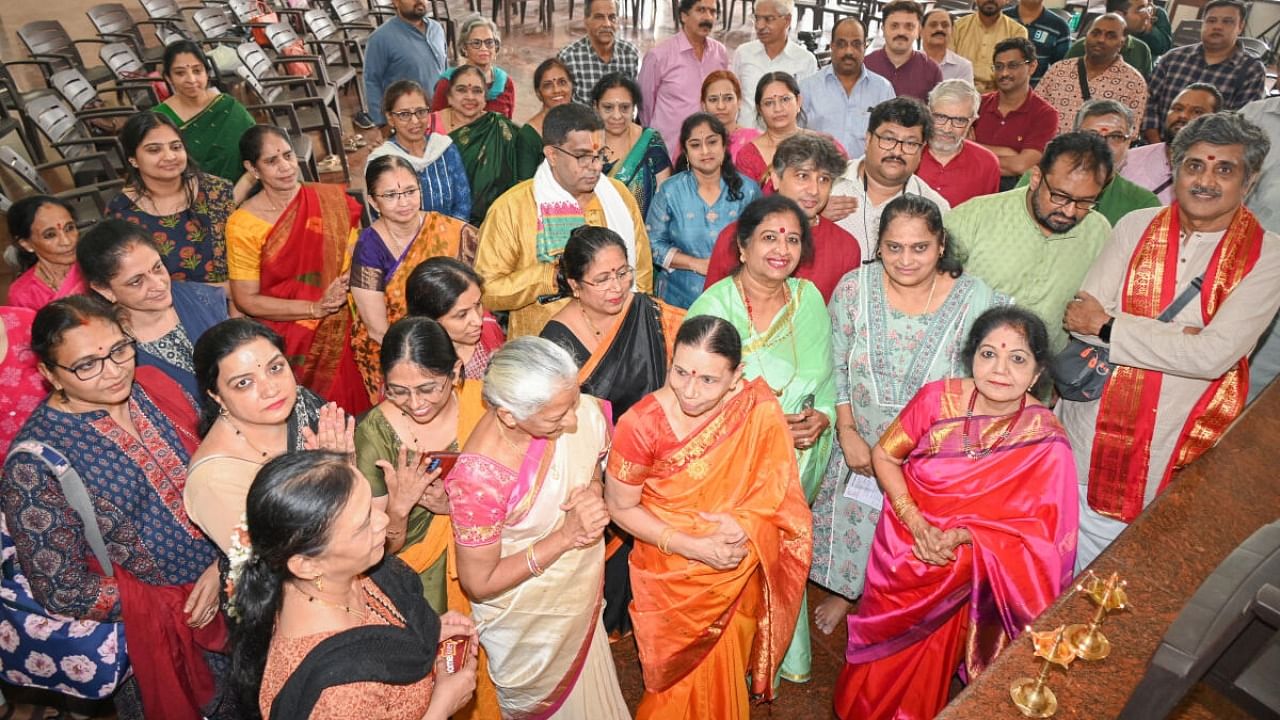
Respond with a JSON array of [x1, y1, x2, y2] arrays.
[[645, 170, 760, 307]]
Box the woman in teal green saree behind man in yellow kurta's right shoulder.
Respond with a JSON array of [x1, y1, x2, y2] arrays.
[[591, 73, 671, 217]]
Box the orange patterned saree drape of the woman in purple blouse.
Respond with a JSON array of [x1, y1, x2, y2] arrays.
[[351, 213, 476, 404]]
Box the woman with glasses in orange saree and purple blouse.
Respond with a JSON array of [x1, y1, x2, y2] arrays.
[[351, 155, 476, 402]]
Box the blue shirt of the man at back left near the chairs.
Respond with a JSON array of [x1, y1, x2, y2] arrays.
[[365, 15, 449, 126]]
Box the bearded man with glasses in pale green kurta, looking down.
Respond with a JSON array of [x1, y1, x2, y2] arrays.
[[942, 132, 1112, 352]]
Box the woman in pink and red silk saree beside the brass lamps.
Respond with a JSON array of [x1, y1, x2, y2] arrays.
[[836, 306, 1079, 720]]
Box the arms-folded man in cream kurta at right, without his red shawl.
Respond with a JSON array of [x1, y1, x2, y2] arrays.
[[1057, 113, 1280, 571]]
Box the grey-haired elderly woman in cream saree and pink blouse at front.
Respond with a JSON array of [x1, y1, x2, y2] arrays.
[[445, 336, 631, 720]]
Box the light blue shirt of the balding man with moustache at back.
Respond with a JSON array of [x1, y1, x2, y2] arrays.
[[800, 65, 896, 158]]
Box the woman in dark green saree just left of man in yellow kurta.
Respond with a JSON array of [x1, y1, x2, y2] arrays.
[[431, 65, 520, 227]]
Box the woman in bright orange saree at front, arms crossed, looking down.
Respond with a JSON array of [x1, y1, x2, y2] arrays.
[[605, 315, 813, 720]]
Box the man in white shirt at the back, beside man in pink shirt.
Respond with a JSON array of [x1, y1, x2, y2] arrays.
[[728, 0, 818, 128]]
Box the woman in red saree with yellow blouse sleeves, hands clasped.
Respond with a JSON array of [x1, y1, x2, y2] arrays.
[[227, 126, 371, 415]]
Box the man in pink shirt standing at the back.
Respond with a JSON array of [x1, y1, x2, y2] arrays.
[[636, 0, 728, 158]]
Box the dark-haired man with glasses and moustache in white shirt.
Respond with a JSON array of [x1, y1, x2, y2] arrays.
[[826, 97, 951, 259]]
